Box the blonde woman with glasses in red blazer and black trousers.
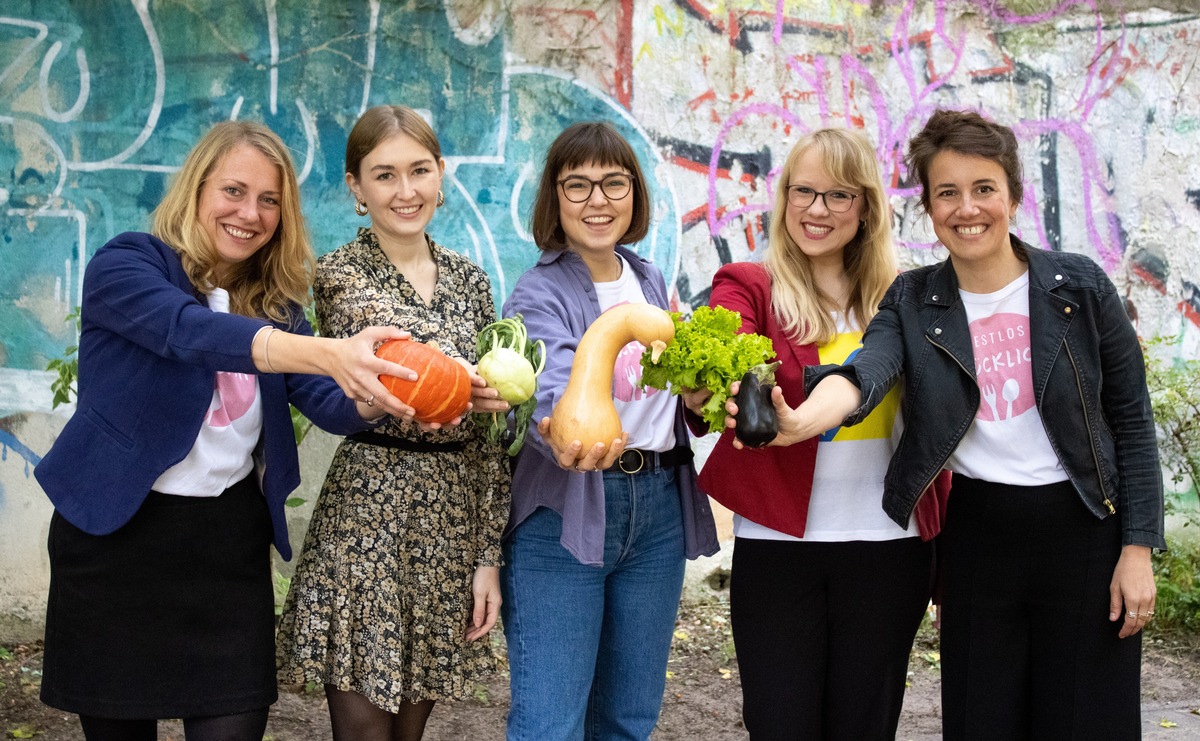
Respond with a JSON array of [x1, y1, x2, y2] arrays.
[[684, 128, 938, 740]]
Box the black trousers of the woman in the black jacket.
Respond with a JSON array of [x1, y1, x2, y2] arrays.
[[938, 475, 1141, 741]]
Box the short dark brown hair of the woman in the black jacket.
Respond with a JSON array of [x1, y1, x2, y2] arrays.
[[905, 109, 1025, 211]]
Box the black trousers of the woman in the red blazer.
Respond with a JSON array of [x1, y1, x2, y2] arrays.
[[730, 537, 932, 741]]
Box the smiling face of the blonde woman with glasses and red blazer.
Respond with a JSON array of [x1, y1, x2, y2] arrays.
[[784, 147, 865, 265]]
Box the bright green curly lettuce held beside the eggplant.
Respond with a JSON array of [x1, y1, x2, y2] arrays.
[[640, 306, 775, 432]]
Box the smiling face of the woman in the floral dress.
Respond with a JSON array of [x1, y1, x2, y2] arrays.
[[346, 132, 445, 243]]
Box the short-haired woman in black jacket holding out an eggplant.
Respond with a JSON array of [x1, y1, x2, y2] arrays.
[[729, 110, 1166, 739]]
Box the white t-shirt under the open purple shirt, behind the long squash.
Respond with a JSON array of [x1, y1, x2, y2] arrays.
[[595, 255, 676, 452]]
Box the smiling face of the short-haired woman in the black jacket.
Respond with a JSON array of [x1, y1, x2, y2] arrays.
[[929, 150, 1018, 271]]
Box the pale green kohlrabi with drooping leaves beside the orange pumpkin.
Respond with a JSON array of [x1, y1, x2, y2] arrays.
[[475, 314, 546, 456]]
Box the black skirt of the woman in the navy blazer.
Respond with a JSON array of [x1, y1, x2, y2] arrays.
[[42, 476, 277, 718]]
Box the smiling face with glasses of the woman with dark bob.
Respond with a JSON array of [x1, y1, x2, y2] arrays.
[[557, 162, 635, 258]]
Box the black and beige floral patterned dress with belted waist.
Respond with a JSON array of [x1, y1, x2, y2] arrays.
[[277, 229, 511, 712]]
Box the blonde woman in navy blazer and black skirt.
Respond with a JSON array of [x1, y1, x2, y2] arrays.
[[35, 121, 432, 741]]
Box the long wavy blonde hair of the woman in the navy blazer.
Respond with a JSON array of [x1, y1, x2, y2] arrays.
[[150, 121, 316, 321]]
